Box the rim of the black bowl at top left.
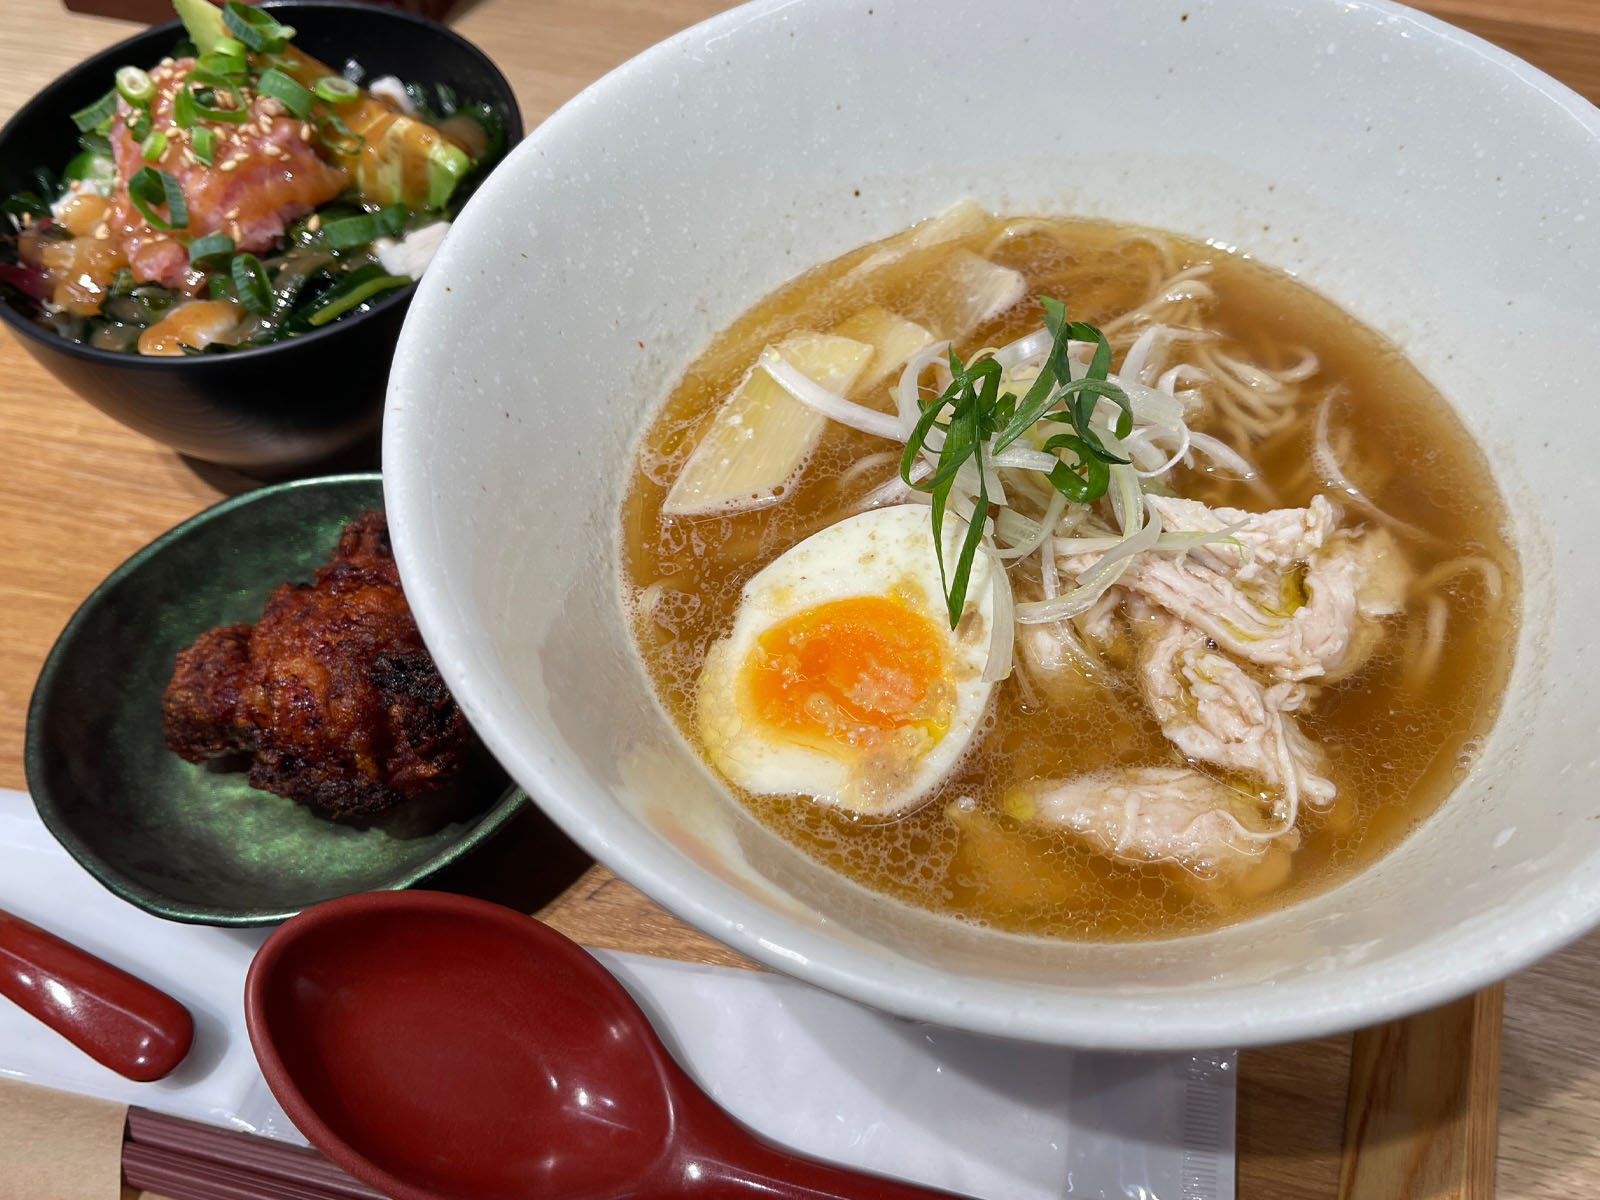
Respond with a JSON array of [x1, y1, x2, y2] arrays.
[[0, 0, 522, 371]]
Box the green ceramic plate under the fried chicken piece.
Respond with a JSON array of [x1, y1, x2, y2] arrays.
[[26, 474, 523, 925]]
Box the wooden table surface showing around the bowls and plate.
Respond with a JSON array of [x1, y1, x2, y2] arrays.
[[0, 0, 1600, 1200]]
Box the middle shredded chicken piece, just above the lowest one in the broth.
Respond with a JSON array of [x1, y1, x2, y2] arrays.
[[1134, 602, 1336, 821]]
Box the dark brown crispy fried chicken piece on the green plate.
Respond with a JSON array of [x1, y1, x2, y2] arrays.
[[162, 510, 475, 816]]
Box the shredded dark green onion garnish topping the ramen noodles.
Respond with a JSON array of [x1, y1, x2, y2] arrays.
[[901, 296, 1133, 629]]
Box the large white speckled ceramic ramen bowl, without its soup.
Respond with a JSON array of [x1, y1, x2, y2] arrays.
[[384, 0, 1600, 1050]]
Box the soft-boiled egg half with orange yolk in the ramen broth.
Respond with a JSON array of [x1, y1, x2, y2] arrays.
[[696, 504, 994, 818]]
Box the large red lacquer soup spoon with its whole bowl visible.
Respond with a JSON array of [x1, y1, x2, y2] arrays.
[[245, 891, 972, 1200]]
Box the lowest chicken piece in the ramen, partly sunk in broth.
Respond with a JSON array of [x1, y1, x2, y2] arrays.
[[1006, 766, 1296, 875]]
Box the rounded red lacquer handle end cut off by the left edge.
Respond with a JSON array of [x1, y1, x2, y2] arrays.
[[0, 912, 194, 1083]]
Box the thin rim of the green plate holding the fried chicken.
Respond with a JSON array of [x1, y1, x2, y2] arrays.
[[22, 470, 526, 928]]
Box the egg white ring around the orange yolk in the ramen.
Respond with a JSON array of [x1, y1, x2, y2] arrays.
[[696, 504, 994, 818]]
